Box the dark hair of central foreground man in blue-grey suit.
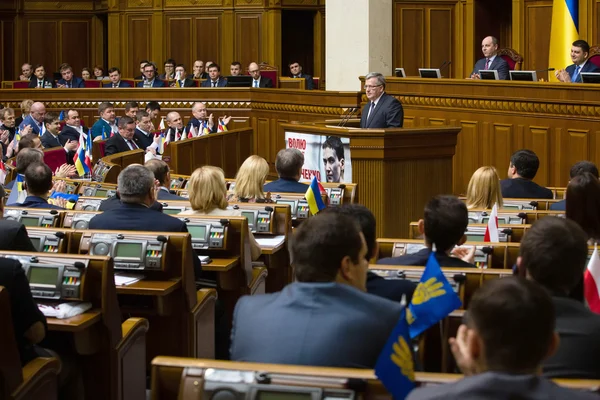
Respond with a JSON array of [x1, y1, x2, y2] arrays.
[[290, 213, 362, 282]]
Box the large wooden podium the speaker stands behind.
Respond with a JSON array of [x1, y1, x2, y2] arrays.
[[281, 120, 461, 238]]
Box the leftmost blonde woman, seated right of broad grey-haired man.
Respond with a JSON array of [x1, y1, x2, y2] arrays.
[[179, 165, 261, 260]]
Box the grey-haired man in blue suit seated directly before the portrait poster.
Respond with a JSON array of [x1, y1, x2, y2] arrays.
[[264, 149, 308, 193]]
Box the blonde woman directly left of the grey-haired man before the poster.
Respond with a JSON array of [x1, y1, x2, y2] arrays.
[[227, 155, 273, 203]]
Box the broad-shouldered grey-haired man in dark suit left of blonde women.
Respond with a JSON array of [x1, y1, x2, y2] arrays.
[[89, 164, 202, 277]]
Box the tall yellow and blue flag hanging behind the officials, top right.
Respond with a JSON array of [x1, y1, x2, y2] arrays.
[[548, 0, 579, 82]]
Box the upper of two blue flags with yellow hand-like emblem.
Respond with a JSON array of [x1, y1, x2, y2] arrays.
[[406, 245, 462, 338]]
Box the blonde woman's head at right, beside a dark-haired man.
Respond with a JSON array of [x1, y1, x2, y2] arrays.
[[467, 167, 502, 210]]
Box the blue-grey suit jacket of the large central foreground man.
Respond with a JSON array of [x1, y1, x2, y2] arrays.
[[231, 282, 402, 368]]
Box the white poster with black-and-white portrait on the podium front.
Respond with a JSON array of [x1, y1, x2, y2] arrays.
[[285, 132, 352, 183]]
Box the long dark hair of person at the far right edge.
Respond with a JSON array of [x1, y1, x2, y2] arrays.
[[566, 172, 600, 239]]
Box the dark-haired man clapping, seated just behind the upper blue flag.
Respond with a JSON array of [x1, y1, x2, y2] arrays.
[[377, 196, 475, 268]]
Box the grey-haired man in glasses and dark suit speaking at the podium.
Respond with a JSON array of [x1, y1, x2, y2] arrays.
[[360, 72, 404, 129]]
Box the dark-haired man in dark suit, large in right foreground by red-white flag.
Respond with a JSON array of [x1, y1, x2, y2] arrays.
[[517, 217, 600, 379]]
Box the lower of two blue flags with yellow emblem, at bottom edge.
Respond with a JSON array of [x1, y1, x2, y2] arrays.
[[375, 309, 415, 400]]
